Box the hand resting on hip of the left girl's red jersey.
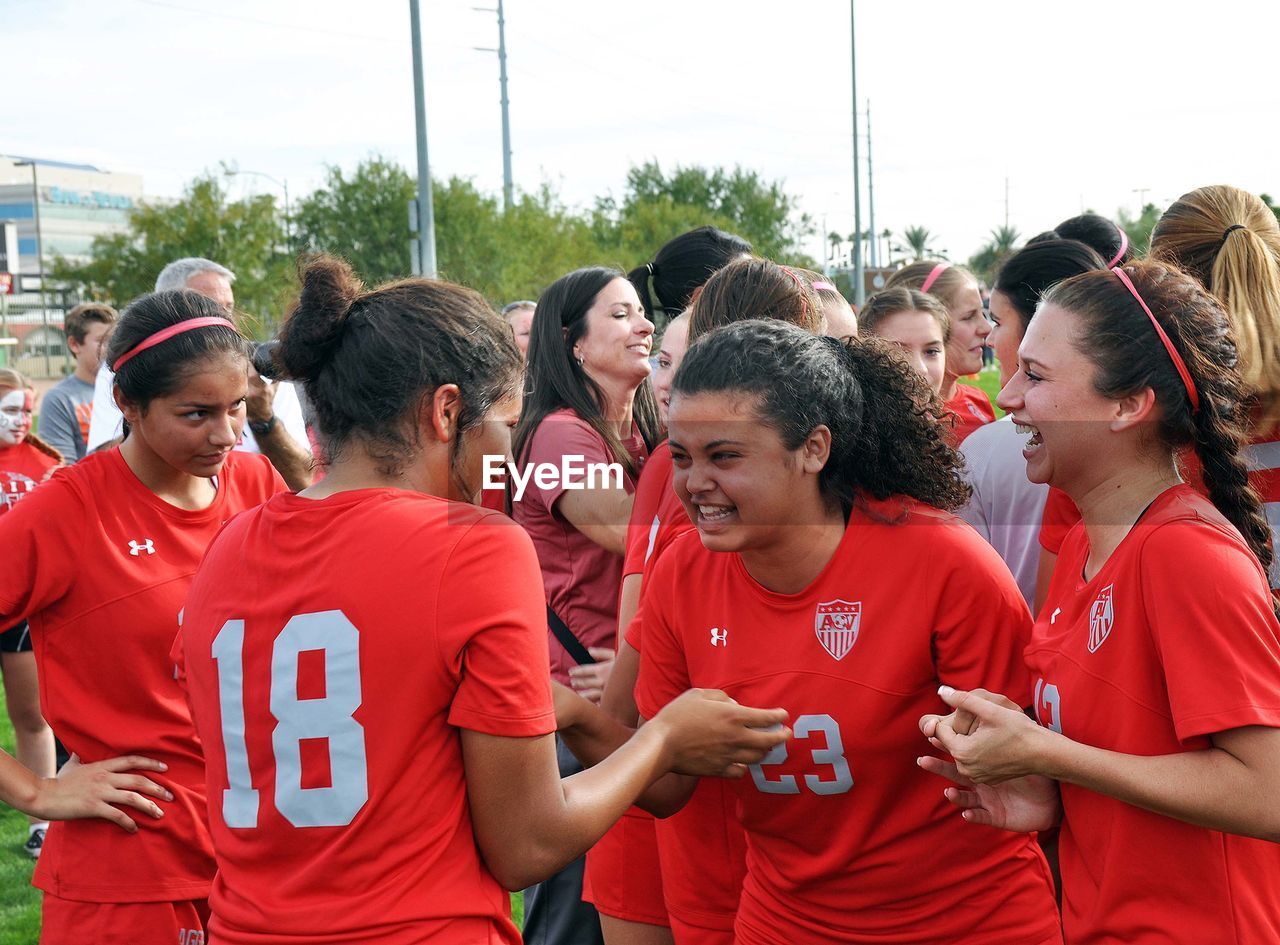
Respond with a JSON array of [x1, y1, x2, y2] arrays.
[[27, 754, 173, 834]]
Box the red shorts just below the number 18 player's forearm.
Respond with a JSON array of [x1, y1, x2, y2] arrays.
[[582, 808, 671, 926]]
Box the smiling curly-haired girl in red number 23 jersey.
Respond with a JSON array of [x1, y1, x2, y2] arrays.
[[636, 321, 1060, 945]]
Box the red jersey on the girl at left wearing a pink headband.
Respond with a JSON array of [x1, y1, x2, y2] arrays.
[[0, 449, 284, 903]]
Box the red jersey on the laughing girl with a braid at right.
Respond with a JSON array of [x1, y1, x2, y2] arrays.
[[1027, 485, 1280, 945]]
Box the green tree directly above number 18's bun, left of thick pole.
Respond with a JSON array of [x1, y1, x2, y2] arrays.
[[293, 155, 414, 284]]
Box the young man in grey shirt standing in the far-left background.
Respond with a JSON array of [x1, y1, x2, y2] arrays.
[[40, 302, 116, 462]]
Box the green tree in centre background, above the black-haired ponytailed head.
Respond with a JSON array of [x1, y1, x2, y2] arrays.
[[593, 161, 814, 268]]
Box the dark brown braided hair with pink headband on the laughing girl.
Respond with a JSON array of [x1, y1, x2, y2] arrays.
[[1044, 261, 1272, 570]]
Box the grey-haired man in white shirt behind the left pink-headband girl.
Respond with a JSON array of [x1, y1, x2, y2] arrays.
[[88, 256, 312, 492]]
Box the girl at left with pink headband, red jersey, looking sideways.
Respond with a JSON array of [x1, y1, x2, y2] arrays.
[[0, 292, 283, 945]]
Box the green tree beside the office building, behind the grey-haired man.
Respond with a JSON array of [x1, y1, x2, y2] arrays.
[[50, 165, 291, 330]]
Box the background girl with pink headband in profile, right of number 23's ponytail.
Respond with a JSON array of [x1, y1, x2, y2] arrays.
[[886, 260, 996, 446]]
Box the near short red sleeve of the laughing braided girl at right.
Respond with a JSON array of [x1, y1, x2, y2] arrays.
[[1140, 520, 1280, 741]]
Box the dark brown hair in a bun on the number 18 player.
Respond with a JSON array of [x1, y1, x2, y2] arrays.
[[276, 256, 520, 475]]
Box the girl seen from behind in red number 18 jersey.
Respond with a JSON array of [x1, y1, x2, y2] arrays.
[[175, 259, 785, 945]]
